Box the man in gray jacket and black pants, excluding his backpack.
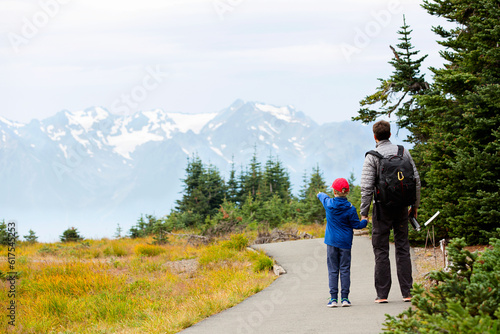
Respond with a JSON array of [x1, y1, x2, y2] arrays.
[[360, 121, 420, 303]]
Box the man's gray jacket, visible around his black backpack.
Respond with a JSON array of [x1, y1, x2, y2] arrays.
[[359, 140, 420, 216]]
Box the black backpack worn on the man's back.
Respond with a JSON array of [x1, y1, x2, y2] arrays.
[[365, 145, 417, 207]]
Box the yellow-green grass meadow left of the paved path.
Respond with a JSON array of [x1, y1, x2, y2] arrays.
[[0, 236, 275, 333]]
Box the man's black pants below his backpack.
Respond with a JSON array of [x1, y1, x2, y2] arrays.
[[372, 203, 413, 299]]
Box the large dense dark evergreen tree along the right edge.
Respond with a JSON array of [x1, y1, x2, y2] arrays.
[[416, 0, 500, 243]]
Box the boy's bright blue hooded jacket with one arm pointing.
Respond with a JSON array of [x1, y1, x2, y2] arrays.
[[318, 193, 368, 249]]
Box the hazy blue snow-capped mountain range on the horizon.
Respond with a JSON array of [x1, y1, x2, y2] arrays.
[[0, 100, 394, 240]]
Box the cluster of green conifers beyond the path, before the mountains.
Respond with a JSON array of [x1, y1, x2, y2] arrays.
[[130, 152, 361, 237]]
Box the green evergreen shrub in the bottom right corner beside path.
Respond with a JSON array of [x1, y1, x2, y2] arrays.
[[384, 238, 500, 333]]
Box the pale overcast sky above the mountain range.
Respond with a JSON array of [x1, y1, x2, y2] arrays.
[[0, 0, 454, 123]]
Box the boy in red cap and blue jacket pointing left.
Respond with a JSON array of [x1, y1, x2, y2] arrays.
[[318, 178, 368, 307]]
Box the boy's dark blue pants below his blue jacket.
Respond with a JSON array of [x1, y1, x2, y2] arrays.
[[326, 245, 351, 299]]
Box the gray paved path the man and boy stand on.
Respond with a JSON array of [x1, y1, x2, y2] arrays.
[[182, 236, 416, 334]]
